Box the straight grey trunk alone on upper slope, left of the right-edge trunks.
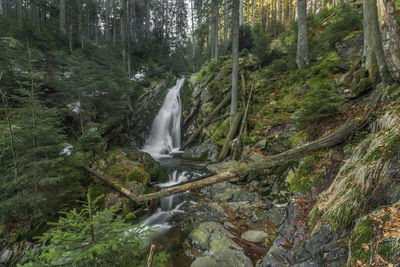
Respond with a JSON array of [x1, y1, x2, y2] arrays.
[[296, 0, 309, 69]]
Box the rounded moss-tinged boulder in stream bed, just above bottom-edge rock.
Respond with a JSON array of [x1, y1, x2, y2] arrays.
[[189, 222, 242, 253]]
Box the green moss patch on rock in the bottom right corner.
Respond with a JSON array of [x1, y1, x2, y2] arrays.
[[350, 219, 374, 263]]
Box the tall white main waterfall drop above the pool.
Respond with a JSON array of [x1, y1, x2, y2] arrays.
[[142, 78, 185, 158]]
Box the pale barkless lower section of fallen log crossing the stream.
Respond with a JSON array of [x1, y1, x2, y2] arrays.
[[136, 172, 237, 202]]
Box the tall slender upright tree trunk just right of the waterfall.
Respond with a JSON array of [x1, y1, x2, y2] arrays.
[[230, 0, 239, 123]]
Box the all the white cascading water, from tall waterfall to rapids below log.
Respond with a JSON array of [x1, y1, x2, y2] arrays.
[[142, 79, 203, 228]]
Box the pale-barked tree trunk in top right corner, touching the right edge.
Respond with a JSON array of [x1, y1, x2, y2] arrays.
[[378, 0, 400, 81]]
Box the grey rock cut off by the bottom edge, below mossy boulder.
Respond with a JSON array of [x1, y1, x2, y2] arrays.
[[191, 249, 253, 267]]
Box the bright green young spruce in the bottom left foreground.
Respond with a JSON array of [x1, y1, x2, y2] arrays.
[[24, 194, 167, 266]]
